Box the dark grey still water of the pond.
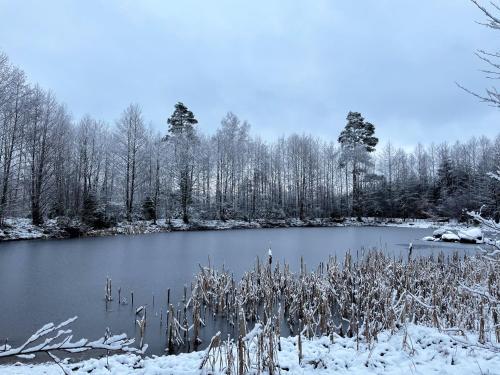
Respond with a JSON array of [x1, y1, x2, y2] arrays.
[[0, 227, 474, 354]]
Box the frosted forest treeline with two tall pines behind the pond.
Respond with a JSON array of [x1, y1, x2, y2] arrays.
[[0, 54, 500, 227]]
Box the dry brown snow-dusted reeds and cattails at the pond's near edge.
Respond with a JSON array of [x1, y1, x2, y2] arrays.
[[186, 251, 500, 373]]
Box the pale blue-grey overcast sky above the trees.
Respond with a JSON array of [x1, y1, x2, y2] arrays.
[[0, 0, 500, 147]]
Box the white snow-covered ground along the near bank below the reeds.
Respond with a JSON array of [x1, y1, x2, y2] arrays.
[[0, 324, 500, 375]]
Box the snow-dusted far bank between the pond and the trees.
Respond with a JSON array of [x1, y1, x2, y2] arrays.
[[0, 218, 446, 241]]
